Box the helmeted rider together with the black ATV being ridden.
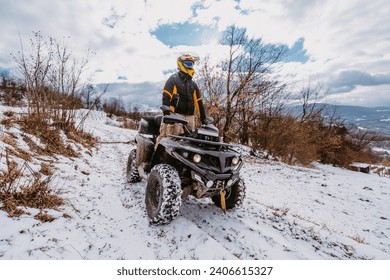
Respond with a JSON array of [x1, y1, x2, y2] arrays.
[[126, 54, 245, 224]]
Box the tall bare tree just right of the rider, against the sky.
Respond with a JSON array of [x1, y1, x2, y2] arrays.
[[201, 26, 286, 142]]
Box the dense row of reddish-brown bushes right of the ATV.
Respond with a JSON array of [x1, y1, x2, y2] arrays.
[[249, 114, 380, 167]]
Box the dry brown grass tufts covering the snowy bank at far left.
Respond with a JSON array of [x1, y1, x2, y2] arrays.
[[0, 108, 96, 222]]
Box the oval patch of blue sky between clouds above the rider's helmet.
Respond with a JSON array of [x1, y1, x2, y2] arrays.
[[151, 22, 218, 47]]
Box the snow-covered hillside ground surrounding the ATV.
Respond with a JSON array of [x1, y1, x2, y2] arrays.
[[0, 108, 390, 260]]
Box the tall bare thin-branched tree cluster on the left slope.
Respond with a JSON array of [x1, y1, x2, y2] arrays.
[[14, 32, 89, 128]]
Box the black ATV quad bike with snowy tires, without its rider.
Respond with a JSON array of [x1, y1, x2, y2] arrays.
[[126, 106, 245, 224]]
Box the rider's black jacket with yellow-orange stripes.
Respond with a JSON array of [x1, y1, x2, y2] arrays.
[[162, 72, 206, 123]]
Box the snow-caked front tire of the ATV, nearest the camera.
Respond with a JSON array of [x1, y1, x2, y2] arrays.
[[145, 164, 182, 224]]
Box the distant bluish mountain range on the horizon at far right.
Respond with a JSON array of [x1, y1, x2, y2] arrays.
[[294, 104, 390, 135]]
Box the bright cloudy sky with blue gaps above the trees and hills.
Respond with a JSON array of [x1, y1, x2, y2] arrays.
[[0, 0, 390, 107]]
